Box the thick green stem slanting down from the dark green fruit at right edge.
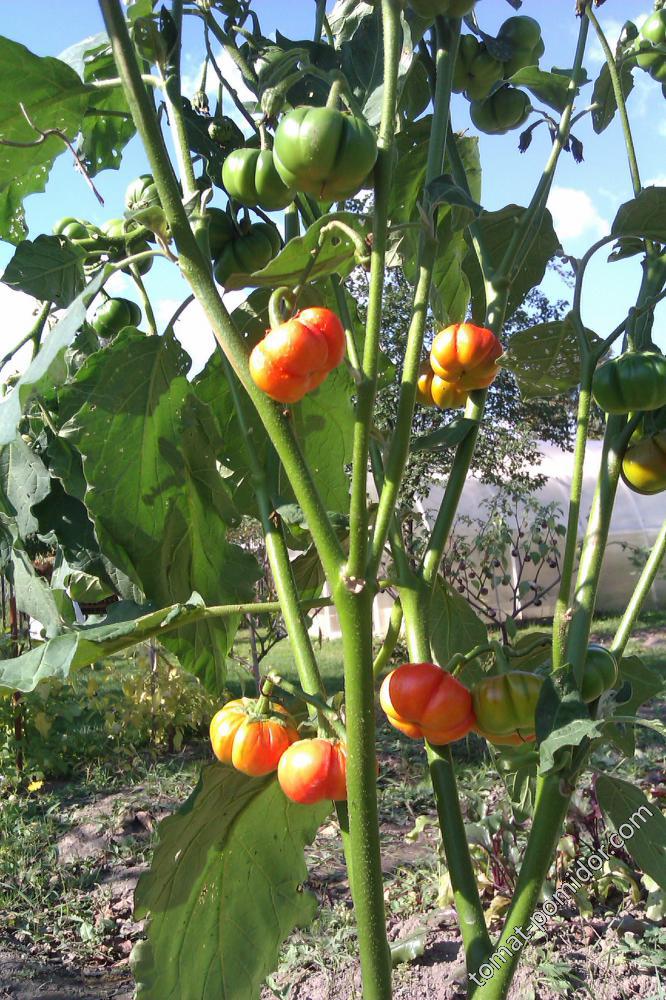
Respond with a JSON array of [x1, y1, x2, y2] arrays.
[[566, 416, 627, 686]]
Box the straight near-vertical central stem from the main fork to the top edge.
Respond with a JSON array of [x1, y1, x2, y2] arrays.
[[347, 0, 402, 585]]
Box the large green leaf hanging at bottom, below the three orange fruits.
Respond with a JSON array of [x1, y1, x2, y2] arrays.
[[132, 764, 330, 1000]]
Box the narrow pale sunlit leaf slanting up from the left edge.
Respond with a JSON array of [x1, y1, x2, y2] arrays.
[[0, 269, 106, 447]]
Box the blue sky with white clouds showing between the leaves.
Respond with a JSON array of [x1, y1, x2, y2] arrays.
[[0, 0, 666, 376]]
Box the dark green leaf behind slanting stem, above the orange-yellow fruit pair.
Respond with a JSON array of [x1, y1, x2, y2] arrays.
[[465, 205, 560, 323]]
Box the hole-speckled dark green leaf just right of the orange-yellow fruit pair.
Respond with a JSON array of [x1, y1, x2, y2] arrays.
[[500, 314, 599, 399]]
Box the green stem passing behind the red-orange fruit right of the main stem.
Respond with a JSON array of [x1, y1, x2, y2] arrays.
[[400, 578, 491, 969]]
